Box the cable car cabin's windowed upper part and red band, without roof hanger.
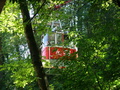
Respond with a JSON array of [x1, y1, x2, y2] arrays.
[[42, 32, 76, 60]]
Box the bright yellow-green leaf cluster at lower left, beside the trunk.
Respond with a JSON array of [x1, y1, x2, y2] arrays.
[[2, 59, 35, 87]]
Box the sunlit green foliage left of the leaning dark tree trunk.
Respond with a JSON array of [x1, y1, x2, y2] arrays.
[[0, 2, 36, 89]]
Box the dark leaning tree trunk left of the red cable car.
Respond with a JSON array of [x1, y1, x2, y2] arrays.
[[19, 0, 48, 90]]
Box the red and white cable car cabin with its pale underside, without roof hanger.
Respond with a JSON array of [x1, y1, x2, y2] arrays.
[[42, 32, 76, 69]]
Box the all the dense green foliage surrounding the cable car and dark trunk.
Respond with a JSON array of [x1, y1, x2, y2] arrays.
[[0, 0, 120, 90]]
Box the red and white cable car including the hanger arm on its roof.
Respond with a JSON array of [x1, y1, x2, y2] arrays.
[[41, 21, 76, 66]]
